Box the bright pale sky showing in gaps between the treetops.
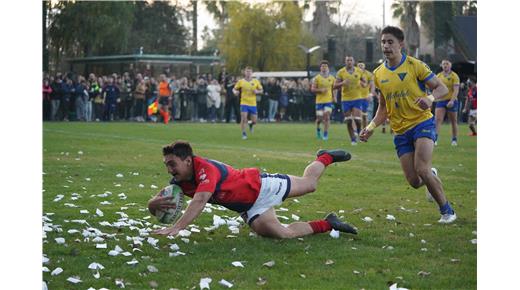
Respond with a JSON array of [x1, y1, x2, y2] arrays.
[[194, 0, 397, 49]]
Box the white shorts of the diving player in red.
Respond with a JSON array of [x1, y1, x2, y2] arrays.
[[240, 173, 291, 225]]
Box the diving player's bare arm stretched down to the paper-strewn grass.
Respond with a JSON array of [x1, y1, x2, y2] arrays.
[[154, 192, 212, 236]]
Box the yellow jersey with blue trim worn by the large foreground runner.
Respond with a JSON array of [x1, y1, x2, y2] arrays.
[[374, 54, 435, 134]]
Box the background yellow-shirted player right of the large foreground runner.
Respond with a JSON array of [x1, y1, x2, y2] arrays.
[[435, 59, 460, 146]]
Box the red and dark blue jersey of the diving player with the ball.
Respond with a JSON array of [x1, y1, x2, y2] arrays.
[[170, 156, 262, 212]]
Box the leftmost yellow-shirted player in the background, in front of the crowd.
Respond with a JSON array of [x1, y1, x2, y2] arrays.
[[233, 66, 263, 139]]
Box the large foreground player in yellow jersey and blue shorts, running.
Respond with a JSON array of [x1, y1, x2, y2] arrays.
[[360, 26, 457, 223]]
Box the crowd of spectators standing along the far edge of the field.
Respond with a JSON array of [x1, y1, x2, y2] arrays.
[[43, 68, 339, 123]]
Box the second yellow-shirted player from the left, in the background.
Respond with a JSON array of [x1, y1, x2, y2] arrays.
[[311, 60, 336, 140]]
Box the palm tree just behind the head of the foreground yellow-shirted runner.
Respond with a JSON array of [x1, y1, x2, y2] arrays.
[[391, 1, 422, 57]]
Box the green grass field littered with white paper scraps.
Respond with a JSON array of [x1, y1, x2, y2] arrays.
[[43, 123, 477, 289]]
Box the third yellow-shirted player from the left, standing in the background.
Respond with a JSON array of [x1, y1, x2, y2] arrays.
[[335, 56, 367, 145]]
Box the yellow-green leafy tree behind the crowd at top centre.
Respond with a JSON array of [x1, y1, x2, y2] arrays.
[[218, 2, 309, 72]]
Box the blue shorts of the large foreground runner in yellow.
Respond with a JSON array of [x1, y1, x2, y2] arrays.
[[394, 118, 437, 157]]
